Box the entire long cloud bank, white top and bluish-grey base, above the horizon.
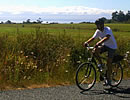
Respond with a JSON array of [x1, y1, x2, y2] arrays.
[[0, 5, 114, 22]]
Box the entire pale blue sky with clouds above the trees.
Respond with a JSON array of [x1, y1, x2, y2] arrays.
[[0, 0, 130, 22]]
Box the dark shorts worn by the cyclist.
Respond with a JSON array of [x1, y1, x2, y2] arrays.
[[100, 45, 116, 58]]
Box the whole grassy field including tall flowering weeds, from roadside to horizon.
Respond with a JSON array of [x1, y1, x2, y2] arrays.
[[0, 24, 130, 88]]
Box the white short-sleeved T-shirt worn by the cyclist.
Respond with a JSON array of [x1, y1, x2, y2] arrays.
[[93, 27, 117, 49]]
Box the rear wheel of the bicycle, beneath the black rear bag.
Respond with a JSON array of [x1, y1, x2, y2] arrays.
[[110, 63, 123, 87]]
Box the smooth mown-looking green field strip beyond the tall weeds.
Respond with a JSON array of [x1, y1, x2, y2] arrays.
[[0, 24, 130, 41]]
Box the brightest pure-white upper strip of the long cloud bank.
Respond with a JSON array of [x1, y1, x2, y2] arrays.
[[0, 5, 114, 15]]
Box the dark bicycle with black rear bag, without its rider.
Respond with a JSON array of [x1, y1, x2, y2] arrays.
[[76, 47, 123, 91]]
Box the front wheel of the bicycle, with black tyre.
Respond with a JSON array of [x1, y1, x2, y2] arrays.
[[76, 63, 96, 91]]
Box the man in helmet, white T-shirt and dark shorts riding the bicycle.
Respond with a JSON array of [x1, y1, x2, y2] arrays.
[[84, 18, 117, 85]]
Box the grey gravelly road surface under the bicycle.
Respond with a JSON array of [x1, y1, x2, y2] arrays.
[[0, 80, 130, 100]]
